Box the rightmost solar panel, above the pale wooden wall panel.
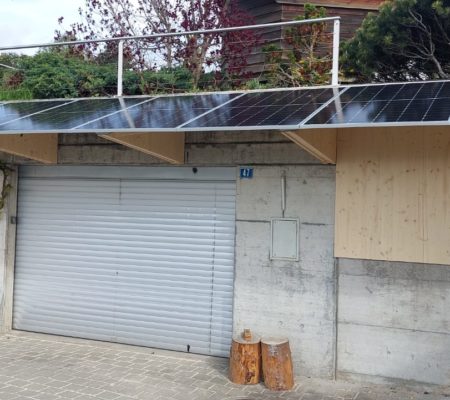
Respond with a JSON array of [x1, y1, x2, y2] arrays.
[[305, 82, 450, 126]]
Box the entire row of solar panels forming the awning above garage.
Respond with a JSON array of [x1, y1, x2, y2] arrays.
[[0, 81, 450, 133]]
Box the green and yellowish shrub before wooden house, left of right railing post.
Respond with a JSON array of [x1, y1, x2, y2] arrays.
[[263, 4, 331, 87]]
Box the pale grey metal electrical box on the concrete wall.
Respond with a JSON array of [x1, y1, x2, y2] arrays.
[[270, 218, 299, 261]]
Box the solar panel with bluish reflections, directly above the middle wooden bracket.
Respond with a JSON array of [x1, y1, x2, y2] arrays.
[[78, 93, 239, 130]]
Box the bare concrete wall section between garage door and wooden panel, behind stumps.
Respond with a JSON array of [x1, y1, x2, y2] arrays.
[[234, 166, 335, 378]]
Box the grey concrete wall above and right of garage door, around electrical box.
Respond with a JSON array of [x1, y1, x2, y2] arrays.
[[0, 132, 335, 378]]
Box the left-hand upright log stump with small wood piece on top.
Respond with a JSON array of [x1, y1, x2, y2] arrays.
[[230, 335, 261, 385]]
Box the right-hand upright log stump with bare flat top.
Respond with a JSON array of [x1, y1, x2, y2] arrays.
[[261, 337, 294, 390]]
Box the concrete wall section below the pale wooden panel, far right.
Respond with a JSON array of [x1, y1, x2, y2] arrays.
[[337, 259, 450, 385]]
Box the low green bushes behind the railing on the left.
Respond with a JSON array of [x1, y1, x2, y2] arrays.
[[0, 49, 193, 100]]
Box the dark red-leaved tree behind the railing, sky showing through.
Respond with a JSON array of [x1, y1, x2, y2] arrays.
[[56, 0, 259, 90]]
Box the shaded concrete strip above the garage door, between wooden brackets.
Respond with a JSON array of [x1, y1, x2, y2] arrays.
[[51, 131, 319, 166]]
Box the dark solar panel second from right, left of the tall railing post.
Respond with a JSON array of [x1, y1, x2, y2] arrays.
[[182, 89, 338, 130]]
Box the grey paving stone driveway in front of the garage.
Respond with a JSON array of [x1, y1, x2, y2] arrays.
[[0, 332, 450, 400]]
